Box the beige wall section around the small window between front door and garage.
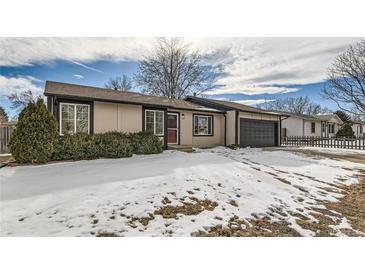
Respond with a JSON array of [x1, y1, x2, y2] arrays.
[[168, 109, 224, 147]]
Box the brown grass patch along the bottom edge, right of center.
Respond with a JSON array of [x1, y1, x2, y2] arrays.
[[191, 217, 300, 237]]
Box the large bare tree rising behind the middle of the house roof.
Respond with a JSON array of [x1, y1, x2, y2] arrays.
[[135, 38, 216, 99]]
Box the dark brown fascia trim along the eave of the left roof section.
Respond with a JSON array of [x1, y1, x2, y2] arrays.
[[44, 92, 223, 114]]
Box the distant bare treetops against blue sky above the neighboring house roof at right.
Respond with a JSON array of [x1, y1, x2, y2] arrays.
[[260, 96, 331, 115]]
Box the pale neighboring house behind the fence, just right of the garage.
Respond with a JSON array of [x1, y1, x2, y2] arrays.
[[282, 112, 342, 138]]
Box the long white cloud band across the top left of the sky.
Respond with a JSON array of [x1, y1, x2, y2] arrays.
[[0, 38, 155, 66]]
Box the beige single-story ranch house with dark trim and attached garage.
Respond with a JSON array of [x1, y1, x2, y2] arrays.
[[44, 81, 286, 147]]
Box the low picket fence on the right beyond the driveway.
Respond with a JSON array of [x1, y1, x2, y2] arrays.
[[281, 136, 365, 150]]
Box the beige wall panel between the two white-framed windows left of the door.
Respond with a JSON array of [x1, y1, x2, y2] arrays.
[[94, 101, 142, 133]]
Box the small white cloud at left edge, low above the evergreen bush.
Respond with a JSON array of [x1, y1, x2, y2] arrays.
[[0, 75, 43, 97]]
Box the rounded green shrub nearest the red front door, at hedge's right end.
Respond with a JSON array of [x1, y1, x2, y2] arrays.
[[129, 132, 163, 154]]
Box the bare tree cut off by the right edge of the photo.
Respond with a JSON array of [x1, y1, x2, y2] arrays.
[[322, 40, 365, 116]]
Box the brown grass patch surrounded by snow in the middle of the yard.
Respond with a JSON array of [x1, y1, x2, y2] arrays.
[[154, 197, 218, 219]]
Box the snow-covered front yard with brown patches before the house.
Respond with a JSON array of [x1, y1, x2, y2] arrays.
[[0, 147, 365, 236]]
